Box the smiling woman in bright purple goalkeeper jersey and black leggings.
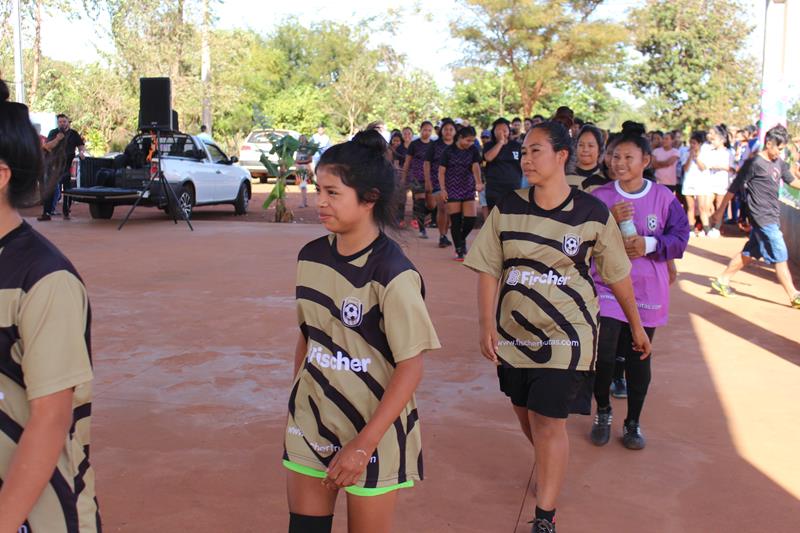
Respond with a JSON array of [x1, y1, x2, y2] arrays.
[[590, 135, 691, 450]]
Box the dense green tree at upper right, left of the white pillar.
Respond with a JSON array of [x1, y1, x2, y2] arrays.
[[629, 0, 759, 128]]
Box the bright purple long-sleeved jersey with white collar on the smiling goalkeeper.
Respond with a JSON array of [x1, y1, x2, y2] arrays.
[[592, 180, 690, 327]]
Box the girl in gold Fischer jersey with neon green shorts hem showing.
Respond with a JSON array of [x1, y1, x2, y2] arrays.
[[283, 131, 439, 533]]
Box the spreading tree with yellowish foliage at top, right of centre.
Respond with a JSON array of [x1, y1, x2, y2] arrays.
[[451, 0, 624, 116]]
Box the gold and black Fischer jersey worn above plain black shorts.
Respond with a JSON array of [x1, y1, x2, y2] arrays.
[[464, 187, 631, 370]]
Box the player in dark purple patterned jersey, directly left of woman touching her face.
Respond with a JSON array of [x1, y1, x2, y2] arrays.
[[439, 126, 483, 261]]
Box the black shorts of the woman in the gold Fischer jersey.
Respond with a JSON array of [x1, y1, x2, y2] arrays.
[[497, 366, 594, 418]]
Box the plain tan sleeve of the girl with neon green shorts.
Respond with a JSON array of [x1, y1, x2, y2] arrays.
[[381, 270, 442, 363]]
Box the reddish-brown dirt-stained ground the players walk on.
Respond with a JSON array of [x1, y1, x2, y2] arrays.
[[20, 193, 800, 533]]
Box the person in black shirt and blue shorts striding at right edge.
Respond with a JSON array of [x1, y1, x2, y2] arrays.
[[711, 126, 800, 309]]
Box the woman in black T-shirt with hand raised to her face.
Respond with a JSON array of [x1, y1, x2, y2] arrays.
[[483, 118, 522, 211]]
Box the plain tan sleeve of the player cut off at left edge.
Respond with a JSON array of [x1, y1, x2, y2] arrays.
[[19, 270, 93, 400]]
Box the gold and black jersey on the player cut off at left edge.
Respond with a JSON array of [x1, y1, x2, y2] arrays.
[[0, 223, 101, 533]]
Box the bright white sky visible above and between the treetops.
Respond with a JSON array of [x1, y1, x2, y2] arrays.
[[42, 0, 784, 92]]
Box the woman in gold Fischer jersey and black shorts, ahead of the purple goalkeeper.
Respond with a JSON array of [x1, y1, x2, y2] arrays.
[[464, 122, 650, 533]]
